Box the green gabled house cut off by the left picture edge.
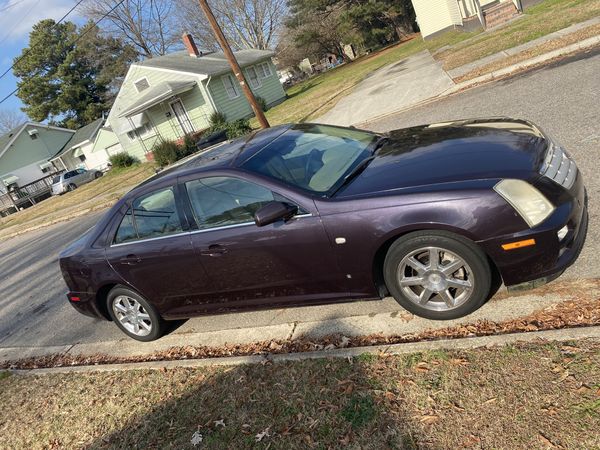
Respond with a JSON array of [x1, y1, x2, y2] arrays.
[[0, 122, 75, 194]]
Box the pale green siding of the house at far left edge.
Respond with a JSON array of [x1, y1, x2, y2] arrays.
[[0, 125, 73, 186]]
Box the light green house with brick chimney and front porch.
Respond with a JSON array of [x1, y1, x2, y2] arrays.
[[107, 35, 285, 160]]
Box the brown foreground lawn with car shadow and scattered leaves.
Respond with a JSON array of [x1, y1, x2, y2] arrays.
[[0, 341, 600, 449]]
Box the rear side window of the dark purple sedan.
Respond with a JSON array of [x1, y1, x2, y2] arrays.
[[114, 188, 183, 244]]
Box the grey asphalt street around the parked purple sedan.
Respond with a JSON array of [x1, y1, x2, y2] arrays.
[[0, 54, 600, 347]]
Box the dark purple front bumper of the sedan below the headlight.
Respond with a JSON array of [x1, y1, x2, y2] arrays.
[[479, 175, 588, 290]]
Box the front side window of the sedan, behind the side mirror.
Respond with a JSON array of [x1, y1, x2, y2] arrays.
[[185, 177, 279, 229]]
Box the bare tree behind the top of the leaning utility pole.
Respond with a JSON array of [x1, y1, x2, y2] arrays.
[[177, 0, 287, 50]]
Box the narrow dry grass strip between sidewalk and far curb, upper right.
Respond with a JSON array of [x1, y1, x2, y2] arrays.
[[454, 24, 600, 83]]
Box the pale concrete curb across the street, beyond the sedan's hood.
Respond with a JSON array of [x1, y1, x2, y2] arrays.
[[353, 36, 600, 126]]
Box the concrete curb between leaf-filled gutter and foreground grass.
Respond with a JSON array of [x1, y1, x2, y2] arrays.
[[10, 326, 600, 376]]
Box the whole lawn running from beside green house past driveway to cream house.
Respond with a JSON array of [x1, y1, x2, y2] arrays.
[[262, 0, 600, 127]]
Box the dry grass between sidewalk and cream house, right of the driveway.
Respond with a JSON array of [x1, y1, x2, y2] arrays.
[[436, 0, 600, 70]]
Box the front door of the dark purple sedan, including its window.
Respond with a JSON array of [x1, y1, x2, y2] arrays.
[[181, 176, 344, 309]]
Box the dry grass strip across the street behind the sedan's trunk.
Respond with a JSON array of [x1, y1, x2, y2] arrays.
[[0, 163, 154, 238]]
